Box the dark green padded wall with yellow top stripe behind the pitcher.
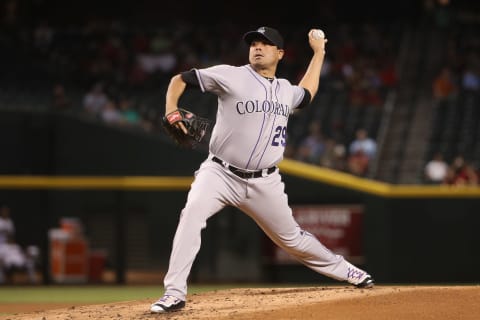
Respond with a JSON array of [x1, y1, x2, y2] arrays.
[[0, 111, 480, 283]]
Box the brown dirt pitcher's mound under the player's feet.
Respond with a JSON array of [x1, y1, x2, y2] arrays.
[[1, 286, 480, 320]]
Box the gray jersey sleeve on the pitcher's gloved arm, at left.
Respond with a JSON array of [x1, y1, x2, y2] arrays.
[[194, 65, 235, 95]]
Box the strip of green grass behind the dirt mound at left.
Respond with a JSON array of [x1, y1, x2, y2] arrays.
[[0, 285, 240, 303]]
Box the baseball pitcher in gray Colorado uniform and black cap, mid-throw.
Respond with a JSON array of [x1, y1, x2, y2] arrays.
[[150, 27, 374, 313]]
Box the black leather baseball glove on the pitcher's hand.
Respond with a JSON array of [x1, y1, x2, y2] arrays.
[[162, 108, 211, 148]]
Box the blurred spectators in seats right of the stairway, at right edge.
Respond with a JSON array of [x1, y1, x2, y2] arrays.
[[423, 1, 480, 186]]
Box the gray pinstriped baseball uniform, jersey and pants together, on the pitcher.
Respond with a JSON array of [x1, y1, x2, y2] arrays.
[[164, 65, 368, 300]]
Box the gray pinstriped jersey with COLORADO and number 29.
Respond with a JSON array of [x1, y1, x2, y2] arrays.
[[196, 65, 305, 170]]
